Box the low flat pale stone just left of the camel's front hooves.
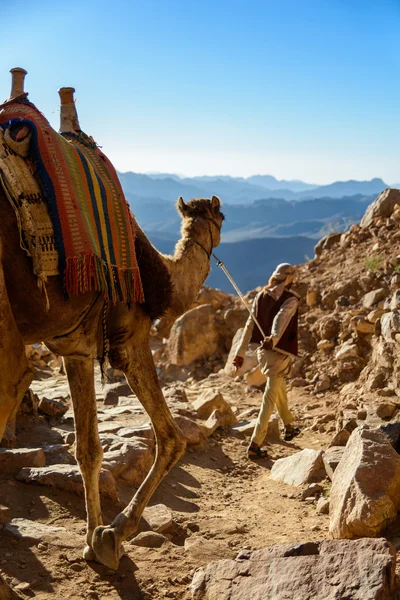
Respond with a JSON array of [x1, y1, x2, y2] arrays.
[[3, 519, 85, 548]]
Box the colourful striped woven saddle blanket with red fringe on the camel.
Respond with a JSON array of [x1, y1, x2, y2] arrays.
[[0, 99, 144, 303]]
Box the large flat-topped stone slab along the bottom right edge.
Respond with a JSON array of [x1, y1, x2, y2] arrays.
[[189, 538, 396, 600]]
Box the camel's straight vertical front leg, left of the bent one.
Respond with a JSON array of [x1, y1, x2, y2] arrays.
[[64, 358, 103, 560]]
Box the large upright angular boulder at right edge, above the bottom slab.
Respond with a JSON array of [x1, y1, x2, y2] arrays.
[[329, 428, 400, 538]]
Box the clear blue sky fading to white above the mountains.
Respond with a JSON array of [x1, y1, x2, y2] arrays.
[[0, 0, 400, 184]]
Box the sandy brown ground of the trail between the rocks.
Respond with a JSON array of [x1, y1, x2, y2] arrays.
[[0, 384, 400, 600]]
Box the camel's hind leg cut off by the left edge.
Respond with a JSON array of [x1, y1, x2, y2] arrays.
[[0, 255, 33, 440]]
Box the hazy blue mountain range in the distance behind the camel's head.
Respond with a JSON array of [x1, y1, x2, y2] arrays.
[[119, 172, 395, 292]]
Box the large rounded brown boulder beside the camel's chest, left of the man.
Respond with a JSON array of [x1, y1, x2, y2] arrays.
[[167, 304, 221, 366]]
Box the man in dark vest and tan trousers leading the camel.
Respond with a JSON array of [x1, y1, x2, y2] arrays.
[[233, 263, 300, 458]]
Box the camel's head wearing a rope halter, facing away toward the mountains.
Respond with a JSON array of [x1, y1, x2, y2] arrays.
[[176, 196, 225, 254]]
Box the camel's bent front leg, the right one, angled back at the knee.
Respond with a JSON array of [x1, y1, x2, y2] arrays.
[[93, 341, 186, 569]]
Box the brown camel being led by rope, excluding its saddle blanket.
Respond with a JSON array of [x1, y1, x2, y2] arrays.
[[0, 79, 224, 569]]
